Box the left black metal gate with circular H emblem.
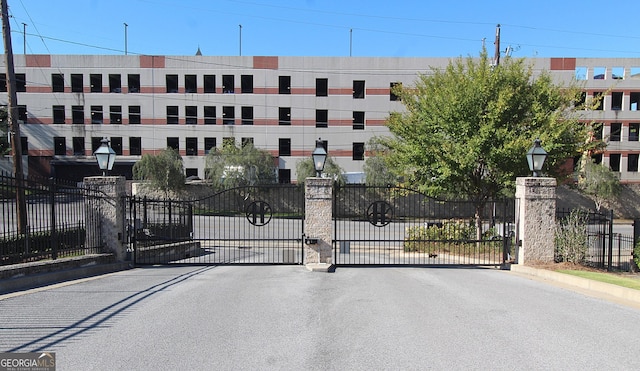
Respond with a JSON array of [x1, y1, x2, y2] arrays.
[[128, 184, 304, 265]]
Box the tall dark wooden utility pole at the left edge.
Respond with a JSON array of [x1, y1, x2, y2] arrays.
[[0, 0, 27, 233]]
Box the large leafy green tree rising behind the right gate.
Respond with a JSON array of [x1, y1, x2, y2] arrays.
[[384, 50, 595, 235]]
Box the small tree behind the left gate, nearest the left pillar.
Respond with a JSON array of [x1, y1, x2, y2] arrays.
[[133, 148, 185, 196]]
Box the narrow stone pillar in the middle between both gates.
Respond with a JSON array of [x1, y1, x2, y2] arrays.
[[304, 178, 333, 271]]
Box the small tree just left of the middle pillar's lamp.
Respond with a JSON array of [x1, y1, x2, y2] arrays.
[[205, 144, 277, 189]]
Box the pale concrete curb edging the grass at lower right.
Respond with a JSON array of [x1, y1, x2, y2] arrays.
[[510, 264, 640, 306]]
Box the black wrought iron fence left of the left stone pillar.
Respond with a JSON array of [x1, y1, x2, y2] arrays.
[[0, 173, 104, 265]]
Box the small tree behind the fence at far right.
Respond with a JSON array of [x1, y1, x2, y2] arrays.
[[578, 161, 622, 211]]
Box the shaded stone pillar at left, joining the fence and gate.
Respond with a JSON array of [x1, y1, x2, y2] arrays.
[[84, 176, 126, 261]]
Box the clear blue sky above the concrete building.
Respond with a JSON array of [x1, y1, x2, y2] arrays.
[[8, 0, 640, 58]]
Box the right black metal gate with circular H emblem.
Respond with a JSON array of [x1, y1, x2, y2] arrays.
[[333, 185, 515, 266]]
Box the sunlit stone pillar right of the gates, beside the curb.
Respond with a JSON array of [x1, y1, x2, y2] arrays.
[[516, 177, 556, 265]]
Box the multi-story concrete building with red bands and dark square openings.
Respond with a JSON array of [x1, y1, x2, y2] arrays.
[[0, 55, 640, 182]]
